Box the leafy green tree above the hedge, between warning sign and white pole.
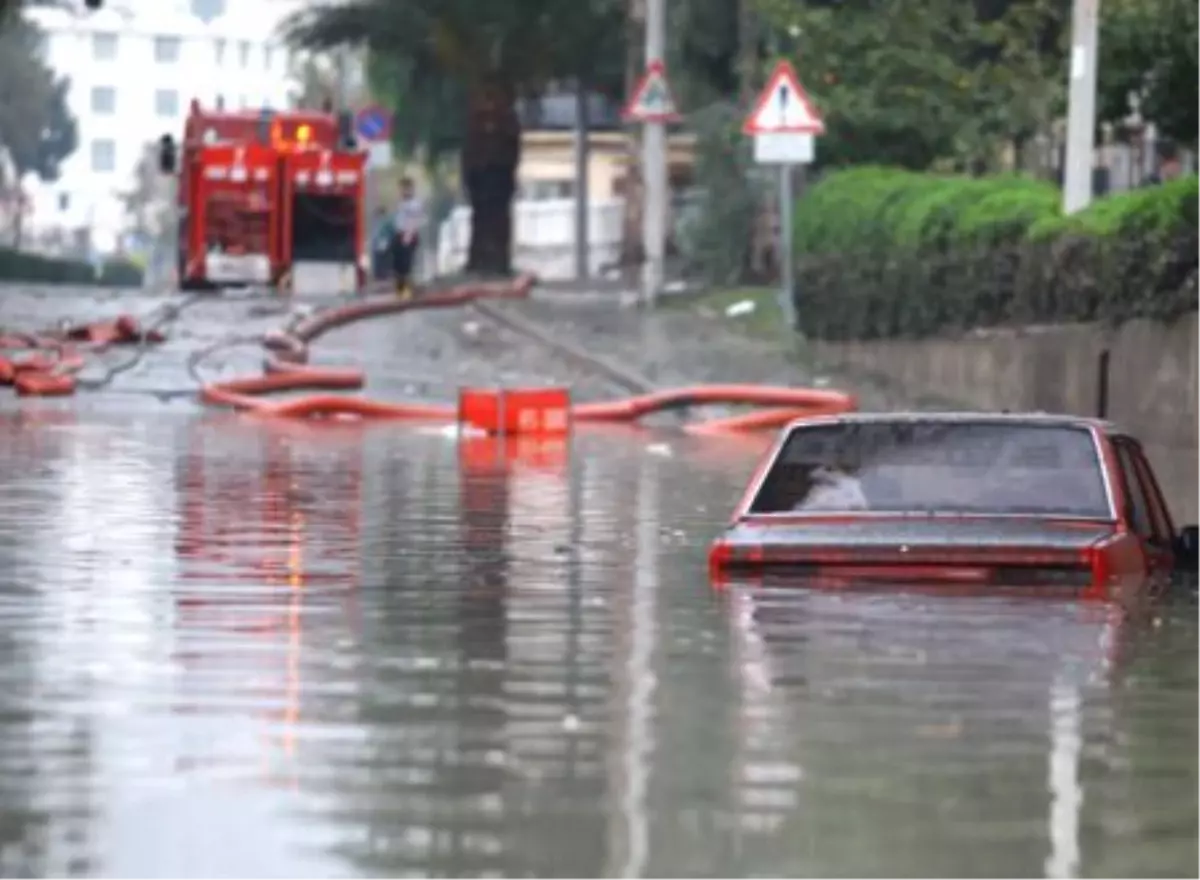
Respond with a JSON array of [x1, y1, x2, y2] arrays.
[[758, 0, 1069, 170]]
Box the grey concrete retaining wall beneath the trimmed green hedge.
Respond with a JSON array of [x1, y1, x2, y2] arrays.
[[814, 315, 1200, 522]]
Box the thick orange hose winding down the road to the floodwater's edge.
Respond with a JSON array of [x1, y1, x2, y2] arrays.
[[200, 276, 856, 435]]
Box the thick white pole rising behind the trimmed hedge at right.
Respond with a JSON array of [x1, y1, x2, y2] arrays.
[[1062, 0, 1100, 214]]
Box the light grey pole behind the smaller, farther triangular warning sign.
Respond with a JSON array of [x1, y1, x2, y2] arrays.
[[642, 0, 667, 306]]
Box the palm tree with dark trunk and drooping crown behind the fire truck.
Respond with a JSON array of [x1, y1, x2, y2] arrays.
[[284, 0, 623, 274]]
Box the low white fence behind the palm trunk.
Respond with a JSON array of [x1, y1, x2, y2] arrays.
[[437, 198, 625, 280]]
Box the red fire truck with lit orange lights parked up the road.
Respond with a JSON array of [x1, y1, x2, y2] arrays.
[[160, 101, 367, 292]]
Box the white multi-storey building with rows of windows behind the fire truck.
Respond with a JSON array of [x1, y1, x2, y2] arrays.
[[25, 0, 307, 253]]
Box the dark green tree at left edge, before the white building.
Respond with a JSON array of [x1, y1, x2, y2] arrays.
[[0, 17, 79, 181]]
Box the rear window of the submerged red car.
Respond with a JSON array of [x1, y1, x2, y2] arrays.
[[750, 419, 1112, 519]]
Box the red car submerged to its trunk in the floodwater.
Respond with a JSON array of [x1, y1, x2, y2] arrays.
[[709, 413, 1200, 595]]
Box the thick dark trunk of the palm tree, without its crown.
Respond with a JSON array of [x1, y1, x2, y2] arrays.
[[462, 82, 521, 275]]
